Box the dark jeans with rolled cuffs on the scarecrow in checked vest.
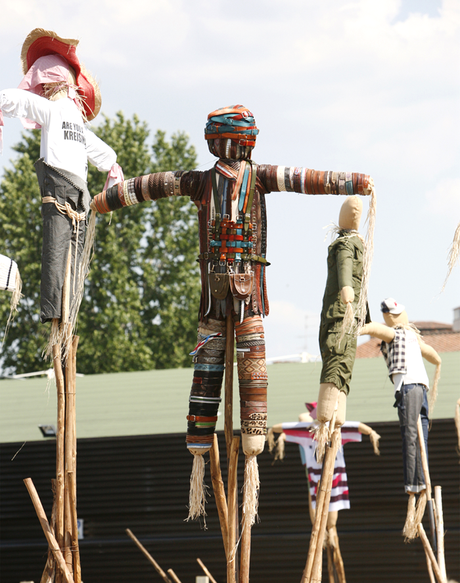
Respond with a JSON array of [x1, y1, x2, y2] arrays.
[[397, 384, 429, 492]]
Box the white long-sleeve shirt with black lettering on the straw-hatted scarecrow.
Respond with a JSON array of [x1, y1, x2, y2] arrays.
[[0, 89, 117, 181]]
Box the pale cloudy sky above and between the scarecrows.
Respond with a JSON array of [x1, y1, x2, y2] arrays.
[[0, 0, 460, 358]]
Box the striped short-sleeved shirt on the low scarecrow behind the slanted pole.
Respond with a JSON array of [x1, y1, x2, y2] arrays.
[[283, 421, 362, 512]]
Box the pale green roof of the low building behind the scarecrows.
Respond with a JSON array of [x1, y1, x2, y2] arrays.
[[0, 352, 460, 443]]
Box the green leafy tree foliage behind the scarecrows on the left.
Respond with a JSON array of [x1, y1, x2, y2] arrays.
[[0, 113, 200, 374]]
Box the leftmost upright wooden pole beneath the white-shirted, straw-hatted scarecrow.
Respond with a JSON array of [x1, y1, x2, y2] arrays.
[[53, 344, 65, 560]]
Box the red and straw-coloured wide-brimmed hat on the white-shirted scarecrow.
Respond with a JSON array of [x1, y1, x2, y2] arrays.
[[21, 28, 101, 121]]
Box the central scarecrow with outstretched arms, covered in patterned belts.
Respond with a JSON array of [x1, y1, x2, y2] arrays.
[[93, 105, 374, 536]]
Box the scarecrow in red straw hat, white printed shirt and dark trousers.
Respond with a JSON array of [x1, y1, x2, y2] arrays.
[[0, 28, 123, 349]]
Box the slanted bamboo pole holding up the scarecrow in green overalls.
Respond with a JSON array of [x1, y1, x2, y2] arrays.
[[301, 428, 340, 583]]
